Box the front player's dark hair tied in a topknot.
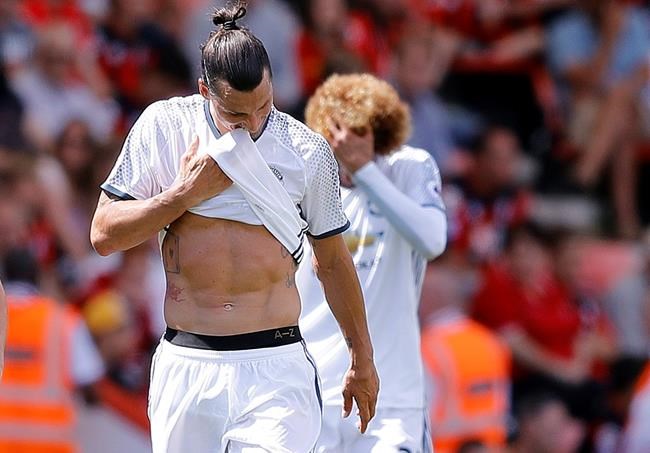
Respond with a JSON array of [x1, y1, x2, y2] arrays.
[[201, 2, 271, 93]]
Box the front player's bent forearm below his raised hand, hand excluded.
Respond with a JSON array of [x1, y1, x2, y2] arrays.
[[90, 185, 188, 255]]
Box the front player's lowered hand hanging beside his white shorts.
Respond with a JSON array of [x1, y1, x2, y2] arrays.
[[343, 360, 379, 433]]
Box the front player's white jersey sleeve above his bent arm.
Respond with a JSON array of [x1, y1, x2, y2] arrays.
[[101, 102, 168, 200]]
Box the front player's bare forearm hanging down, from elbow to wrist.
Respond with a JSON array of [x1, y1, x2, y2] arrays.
[[315, 238, 373, 366]]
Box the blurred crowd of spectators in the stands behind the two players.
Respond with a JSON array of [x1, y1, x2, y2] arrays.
[[0, 0, 650, 453]]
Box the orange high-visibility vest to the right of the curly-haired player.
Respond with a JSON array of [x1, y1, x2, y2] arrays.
[[422, 316, 510, 453]]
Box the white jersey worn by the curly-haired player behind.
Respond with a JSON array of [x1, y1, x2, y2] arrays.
[[296, 146, 444, 408]]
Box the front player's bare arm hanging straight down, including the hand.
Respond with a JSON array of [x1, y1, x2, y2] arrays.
[[311, 235, 379, 432]]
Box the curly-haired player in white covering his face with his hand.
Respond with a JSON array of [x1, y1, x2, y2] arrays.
[[297, 74, 447, 453]]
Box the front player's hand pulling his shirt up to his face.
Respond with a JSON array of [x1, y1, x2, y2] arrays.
[[176, 137, 232, 207]]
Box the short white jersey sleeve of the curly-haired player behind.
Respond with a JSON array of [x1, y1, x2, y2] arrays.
[[399, 149, 445, 211]]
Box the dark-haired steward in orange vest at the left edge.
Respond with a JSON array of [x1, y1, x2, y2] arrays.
[[0, 250, 103, 453]]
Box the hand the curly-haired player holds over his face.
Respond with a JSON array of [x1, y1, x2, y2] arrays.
[[328, 121, 375, 174]]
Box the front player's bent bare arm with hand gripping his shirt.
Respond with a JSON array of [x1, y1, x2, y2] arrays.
[[90, 139, 232, 255]]
